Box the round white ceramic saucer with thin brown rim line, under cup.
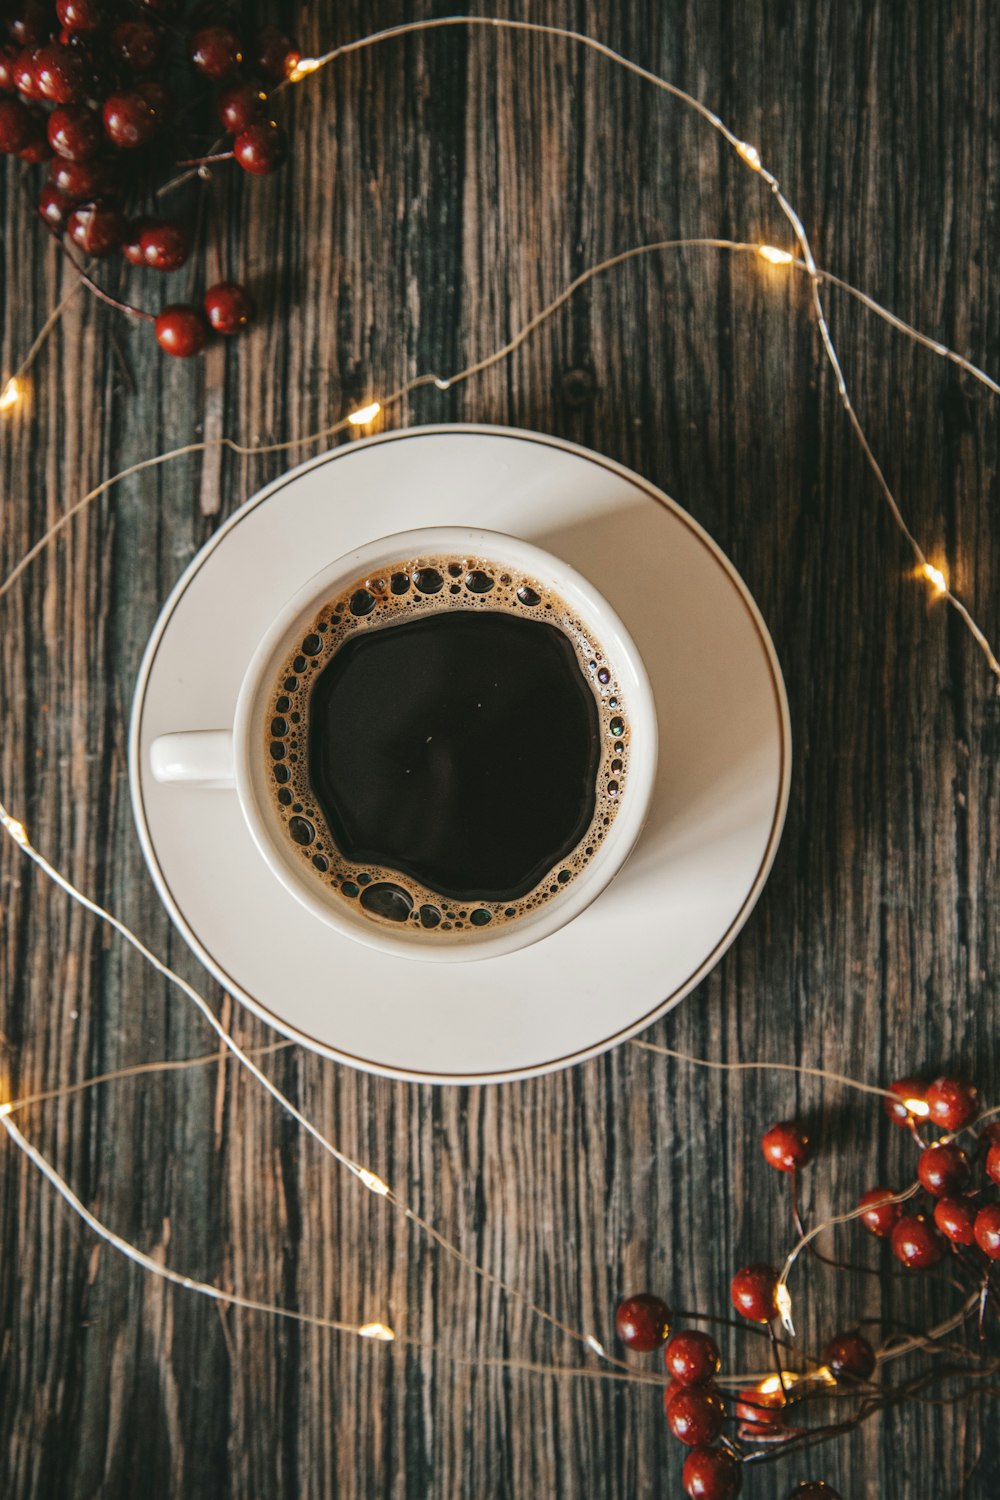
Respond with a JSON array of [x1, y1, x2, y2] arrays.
[[129, 426, 792, 1083]]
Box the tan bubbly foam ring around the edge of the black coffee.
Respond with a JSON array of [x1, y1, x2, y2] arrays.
[[262, 555, 630, 941]]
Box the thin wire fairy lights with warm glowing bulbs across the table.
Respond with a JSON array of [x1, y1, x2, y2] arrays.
[[0, 8, 1000, 1457]]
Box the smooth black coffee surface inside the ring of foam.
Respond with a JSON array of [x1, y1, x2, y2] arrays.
[[307, 611, 600, 902]]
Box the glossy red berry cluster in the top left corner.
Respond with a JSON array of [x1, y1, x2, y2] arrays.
[[0, 0, 298, 356]]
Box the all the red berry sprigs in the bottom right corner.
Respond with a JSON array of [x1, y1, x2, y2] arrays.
[[615, 1076, 1000, 1500]]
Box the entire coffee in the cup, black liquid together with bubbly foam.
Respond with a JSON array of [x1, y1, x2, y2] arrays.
[[264, 557, 630, 935]]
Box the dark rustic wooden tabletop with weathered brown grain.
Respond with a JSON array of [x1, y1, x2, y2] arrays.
[[0, 0, 1000, 1500]]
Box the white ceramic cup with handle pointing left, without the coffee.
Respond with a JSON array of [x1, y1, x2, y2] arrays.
[[150, 527, 657, 962]]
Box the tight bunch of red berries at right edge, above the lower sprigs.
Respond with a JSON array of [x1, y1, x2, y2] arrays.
[[859, 1076, 1000, 1272]]
